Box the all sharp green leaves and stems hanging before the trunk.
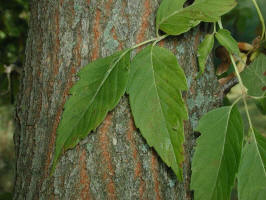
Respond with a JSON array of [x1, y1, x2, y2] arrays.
[[48, 0, 266, 200]]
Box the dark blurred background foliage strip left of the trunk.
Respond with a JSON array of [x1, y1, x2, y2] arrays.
[[0, 0, 29, 197]]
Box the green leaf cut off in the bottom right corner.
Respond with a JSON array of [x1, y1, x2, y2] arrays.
[[238, 130, 266, 200]]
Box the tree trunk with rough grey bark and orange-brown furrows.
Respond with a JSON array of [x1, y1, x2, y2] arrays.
[[14, 0, 221, 200]]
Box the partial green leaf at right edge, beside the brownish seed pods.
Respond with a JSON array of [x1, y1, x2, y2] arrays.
[[240, 54, 266, 96]]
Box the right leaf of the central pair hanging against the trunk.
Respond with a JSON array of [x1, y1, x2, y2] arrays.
[[128, 46, 188, 180]]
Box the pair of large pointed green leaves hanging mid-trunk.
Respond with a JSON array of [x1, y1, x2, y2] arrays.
[[53, 44, 188, 180]]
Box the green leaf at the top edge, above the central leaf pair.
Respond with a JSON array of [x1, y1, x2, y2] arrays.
[[156, 0, 236, 35]]
